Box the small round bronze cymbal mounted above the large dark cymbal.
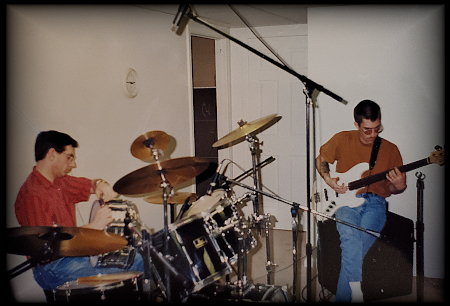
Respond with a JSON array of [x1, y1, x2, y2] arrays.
[[130, 131, 170, 160]]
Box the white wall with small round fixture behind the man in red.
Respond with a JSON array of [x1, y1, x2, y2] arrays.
[[6, 5, 194, 301]]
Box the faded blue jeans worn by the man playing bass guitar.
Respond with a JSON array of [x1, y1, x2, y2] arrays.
[[335, 194, 386, 302]]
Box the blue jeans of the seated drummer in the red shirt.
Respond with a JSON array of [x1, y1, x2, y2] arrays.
[[33, 253, 144, 290]]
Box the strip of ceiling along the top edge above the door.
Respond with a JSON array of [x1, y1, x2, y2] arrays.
[[136, 4, 323, 28]]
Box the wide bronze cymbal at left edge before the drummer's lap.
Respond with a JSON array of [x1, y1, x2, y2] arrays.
[[6, 226, 127, 256]]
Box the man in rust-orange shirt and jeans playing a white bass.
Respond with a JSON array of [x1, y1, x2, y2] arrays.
[[316, 100, 406, 302]]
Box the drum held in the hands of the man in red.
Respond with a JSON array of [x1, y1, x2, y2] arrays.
[[89, 200, 142, 269]]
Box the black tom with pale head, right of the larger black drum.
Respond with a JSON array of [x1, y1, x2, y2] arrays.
[[186, 189, 256, 264]]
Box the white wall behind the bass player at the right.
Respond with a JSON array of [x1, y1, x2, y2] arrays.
[[308, 6, 445, 278]]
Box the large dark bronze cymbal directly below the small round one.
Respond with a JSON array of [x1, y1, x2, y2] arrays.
[[113, 157, 210, 195]]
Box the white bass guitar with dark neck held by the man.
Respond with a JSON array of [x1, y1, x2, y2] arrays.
[[314, 146, 445, 220]]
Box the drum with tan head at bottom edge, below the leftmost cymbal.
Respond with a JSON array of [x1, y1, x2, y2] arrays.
[[54, 271, 143, 302]]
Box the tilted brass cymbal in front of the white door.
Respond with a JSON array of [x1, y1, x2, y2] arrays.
[[213, 114, 281, 148]]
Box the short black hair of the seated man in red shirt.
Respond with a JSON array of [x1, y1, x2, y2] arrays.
[[34, 131, 78, 161]]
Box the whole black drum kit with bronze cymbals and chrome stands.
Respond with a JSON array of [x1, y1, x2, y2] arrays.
[[7, 114, 296, 302]]
